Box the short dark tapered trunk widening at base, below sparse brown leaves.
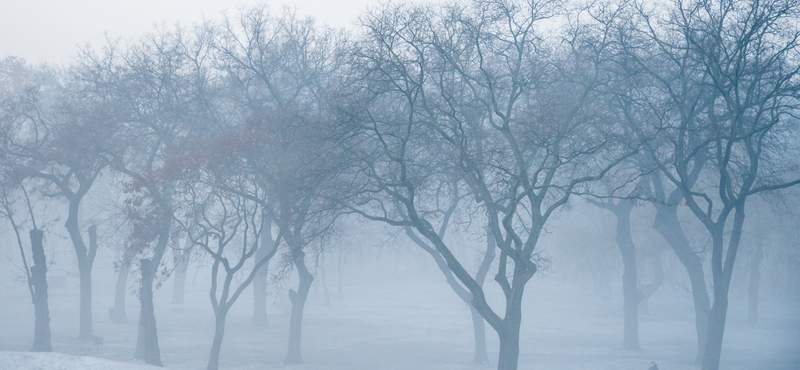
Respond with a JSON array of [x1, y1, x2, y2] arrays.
[[134, 259, 162, 366]]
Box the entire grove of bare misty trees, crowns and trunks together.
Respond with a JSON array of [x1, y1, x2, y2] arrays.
[[0, 0, 800, 370]]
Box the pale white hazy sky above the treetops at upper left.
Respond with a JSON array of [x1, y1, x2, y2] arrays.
[[0, 0, 378, 63]]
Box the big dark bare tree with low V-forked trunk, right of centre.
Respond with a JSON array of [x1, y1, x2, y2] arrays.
[[342, 1, 635, 369]]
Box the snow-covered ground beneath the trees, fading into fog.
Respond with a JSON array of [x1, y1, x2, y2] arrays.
[[0, 258, 800, 370]]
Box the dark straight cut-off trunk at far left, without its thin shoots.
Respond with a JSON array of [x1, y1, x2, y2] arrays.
[[30, 230, 53, 352]]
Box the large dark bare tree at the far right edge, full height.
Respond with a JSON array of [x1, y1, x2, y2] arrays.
[[628, 1, 800, 370]]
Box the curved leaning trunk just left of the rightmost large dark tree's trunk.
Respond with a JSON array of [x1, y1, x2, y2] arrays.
[[653, 204, 711, 364]]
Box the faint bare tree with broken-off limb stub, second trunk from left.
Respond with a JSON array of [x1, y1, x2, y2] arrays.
[[2, 53, 120, 340]]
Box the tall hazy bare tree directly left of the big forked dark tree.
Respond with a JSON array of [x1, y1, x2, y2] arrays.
[[216, 7, 338, 363]]
